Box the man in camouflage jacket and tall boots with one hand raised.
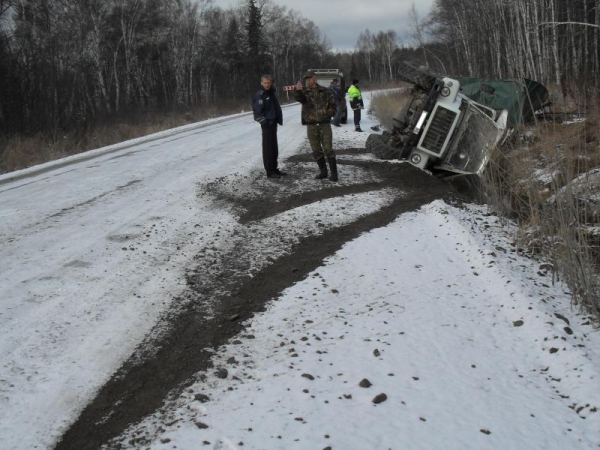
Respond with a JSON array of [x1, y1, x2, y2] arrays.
[[294, 72, 338, 181]]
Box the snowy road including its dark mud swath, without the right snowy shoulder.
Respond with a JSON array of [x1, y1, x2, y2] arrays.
[[0, 100, 454, 449]]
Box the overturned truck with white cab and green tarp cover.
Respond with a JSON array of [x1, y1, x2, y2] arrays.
[[366, 63, 548, 176]]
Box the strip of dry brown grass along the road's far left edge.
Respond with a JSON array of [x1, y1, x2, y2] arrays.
[[0, 105, 249, 173]]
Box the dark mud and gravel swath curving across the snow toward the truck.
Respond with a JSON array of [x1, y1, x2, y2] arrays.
[[56, 148, 465, 450]]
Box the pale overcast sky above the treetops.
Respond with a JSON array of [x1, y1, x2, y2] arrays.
[[214, 0, 434, 50]]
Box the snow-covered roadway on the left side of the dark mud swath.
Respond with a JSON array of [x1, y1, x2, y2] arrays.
[[0, 105, 306, 448]]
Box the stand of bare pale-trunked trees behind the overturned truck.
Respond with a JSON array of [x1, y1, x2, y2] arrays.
[[429, 0, 600, 94]]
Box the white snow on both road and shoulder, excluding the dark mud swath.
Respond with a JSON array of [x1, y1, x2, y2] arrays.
[[0, 97, 600, 450]]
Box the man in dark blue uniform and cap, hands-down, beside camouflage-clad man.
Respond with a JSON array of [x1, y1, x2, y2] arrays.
[[252, 75, 287, 178]]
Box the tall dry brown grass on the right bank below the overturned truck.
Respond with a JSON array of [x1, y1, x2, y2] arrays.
[[486, 104, 600, 322]]
